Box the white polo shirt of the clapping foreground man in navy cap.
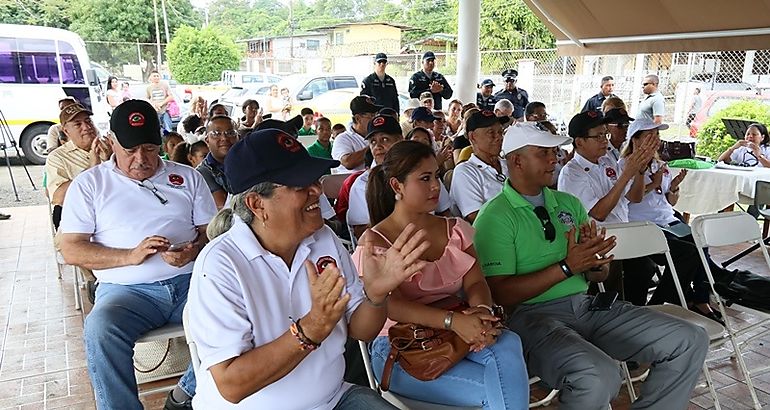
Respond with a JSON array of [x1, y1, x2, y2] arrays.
[[187, 216, 363, 410]]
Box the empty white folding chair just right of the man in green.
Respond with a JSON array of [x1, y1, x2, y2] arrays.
[[600, 222, 724, 410]]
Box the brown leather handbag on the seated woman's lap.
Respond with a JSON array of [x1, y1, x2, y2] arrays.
[[380, 298, 470, 391]]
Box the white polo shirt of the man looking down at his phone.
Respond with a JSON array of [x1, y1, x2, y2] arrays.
[[59, 156, 217, 285]]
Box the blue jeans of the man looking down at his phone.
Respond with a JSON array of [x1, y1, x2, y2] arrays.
[[83, 274, 195, 410]]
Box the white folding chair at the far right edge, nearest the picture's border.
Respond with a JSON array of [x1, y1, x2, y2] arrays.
[[691, 212, 770, 409]]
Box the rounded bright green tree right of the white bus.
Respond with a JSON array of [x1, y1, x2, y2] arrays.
[[166, 26, 242, 84]]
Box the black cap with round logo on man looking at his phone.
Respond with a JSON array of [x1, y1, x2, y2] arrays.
[[110, 100, 161, 149]]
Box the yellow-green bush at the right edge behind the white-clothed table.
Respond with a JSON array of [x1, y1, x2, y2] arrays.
[[695, 100, 770, 159]]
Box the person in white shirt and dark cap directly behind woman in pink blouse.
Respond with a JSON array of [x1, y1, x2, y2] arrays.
[[347, 115, 451, 238]]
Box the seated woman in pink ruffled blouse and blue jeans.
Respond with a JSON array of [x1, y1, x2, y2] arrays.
[[353, 141, 529, 409]]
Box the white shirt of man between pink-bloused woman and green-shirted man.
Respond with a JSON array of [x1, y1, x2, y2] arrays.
[[449, 154, 508, 218]]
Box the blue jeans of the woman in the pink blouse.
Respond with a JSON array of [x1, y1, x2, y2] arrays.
[[371, 330, 529, 410]]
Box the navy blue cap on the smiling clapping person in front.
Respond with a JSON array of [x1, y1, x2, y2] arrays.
[[225, 128, 340, 194]]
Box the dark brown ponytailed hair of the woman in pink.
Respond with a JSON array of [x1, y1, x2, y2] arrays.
[[366, 141, 436, 226]]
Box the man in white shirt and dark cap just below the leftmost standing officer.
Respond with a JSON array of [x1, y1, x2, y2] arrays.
[[332, 95, 382, 174]]
